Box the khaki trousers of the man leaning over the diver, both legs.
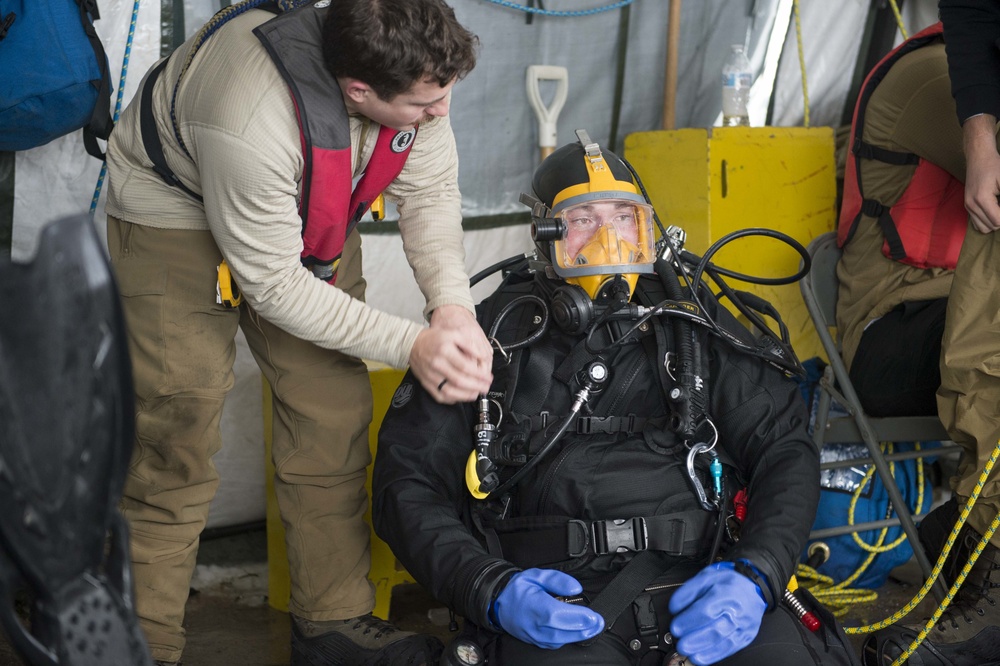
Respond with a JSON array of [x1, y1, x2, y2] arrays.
[[108, 217, 375, 661]]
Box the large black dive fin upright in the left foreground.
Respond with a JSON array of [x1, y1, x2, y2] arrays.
[[0, 217, 152, 666]]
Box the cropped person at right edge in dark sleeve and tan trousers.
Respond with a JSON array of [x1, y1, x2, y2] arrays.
[[866, 0, 1000, 666]]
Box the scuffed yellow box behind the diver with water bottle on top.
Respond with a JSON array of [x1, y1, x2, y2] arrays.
[[624, 127, 837, 360]]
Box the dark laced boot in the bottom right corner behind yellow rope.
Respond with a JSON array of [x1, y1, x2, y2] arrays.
[[863, 528, 1000, 666]]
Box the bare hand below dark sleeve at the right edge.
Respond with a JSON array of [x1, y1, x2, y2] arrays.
[[962, 114, 1000, 234]]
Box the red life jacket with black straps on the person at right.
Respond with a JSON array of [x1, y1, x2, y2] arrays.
[[837, 22, 968, 269]]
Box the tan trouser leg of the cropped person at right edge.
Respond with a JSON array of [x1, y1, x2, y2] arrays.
[[938, 227, 1000, 546]]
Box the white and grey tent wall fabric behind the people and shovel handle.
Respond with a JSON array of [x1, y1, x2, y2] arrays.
[[5, 0, 936, 526]]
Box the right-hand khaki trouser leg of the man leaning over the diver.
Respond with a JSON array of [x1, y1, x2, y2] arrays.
[[241, 233, 375, 620]]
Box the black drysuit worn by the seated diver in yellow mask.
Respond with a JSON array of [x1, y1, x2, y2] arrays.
[[373, 272, 851, 664]]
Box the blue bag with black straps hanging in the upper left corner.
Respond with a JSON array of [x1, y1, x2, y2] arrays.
[[0, 0, 112, 154]]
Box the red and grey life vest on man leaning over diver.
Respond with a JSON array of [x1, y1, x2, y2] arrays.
[[254, 3, 417, 283]]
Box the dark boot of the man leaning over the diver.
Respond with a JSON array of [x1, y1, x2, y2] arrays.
[[292, 614, 444, 666]]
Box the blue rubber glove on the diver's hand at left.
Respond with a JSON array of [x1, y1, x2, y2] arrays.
[[493, 569, 604, 650]]
